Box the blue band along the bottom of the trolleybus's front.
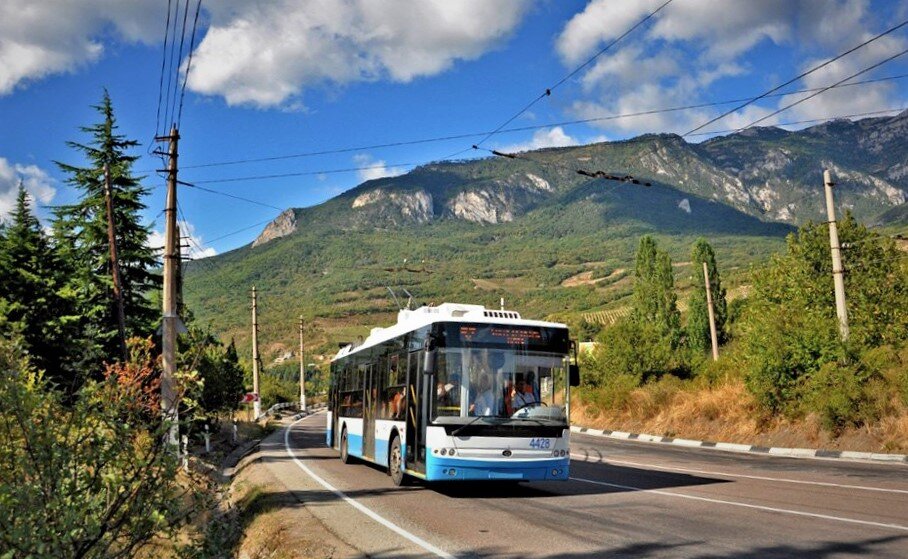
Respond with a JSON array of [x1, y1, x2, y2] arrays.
[[426, 456, 570, 481]]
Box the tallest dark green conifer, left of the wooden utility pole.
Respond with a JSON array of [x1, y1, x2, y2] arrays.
[[54, 91, 160, 380]]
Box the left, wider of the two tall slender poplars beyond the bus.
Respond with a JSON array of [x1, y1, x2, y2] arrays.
[[631, 235, 681, 346]]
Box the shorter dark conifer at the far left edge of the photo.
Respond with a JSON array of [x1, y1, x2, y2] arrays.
[[0, 184, 68, 380]]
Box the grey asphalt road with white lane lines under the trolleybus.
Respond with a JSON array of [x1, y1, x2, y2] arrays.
[[262, 415, 908, 559]]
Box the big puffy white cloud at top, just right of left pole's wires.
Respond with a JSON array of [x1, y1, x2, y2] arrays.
[[189, 0, 529, 107]]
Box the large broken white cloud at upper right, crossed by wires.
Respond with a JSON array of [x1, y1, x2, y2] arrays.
[[556, 0, 904, 138]]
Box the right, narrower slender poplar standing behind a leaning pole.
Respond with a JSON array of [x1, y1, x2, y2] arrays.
[[686, 238, 728, 352]]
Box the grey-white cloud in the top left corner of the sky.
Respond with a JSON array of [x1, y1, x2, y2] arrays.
[[0, 0, 166, 95]]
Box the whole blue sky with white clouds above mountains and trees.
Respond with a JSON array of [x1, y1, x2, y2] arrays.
[[0, 0, 908, 254]]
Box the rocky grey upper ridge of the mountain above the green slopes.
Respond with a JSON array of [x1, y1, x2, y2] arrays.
[[247, 111, 908, 246]]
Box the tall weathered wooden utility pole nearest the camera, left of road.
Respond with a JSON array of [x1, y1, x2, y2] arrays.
[[155, 126, 180, 446]]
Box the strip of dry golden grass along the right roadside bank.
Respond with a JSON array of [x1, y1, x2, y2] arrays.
[[571, 379, 908, 453]]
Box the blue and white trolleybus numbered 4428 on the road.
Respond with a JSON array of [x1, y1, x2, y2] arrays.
[[327, 303, 579, 485]]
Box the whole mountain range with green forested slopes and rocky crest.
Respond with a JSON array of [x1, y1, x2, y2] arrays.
[[185, 111, 908, 358]]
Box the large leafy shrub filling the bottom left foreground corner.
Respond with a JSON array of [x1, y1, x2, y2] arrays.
[[0, 340, 202, 557]]
